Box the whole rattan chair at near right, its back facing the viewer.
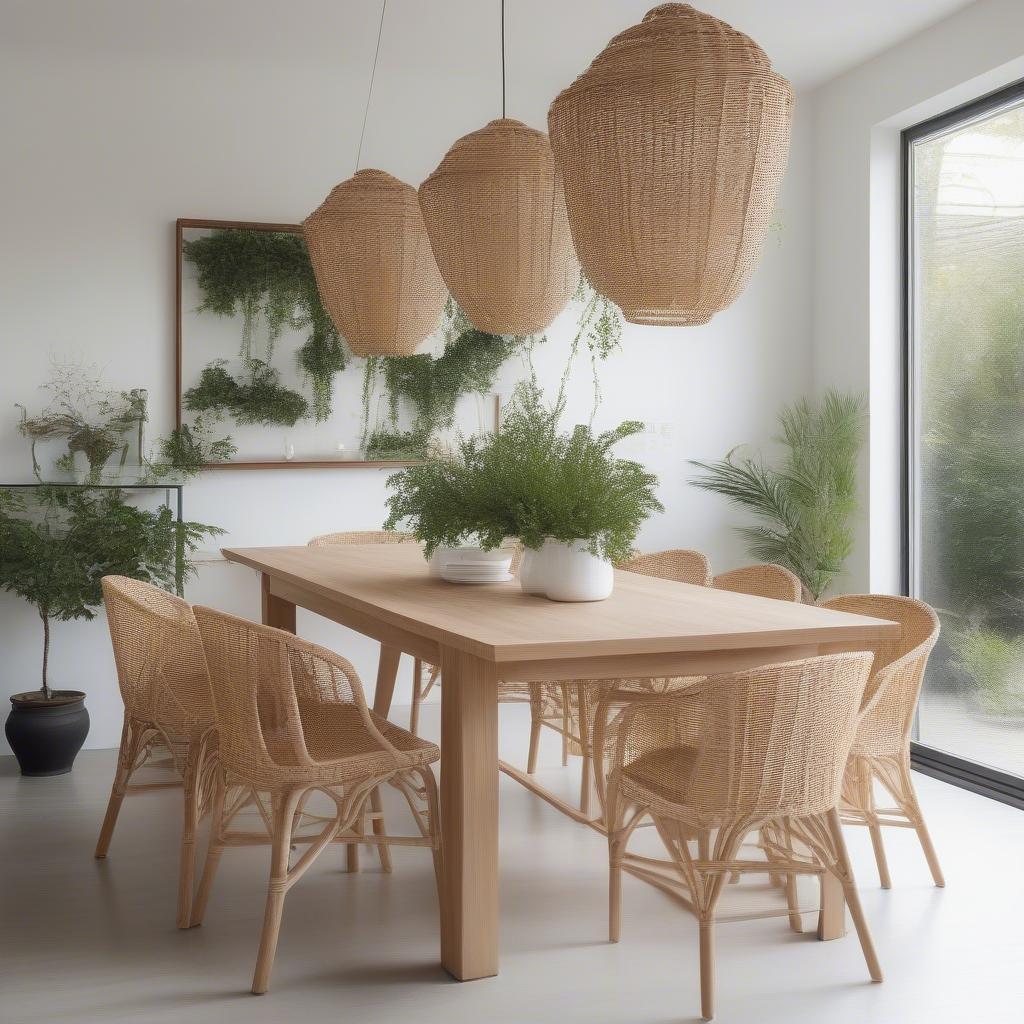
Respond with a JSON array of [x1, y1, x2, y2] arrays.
[[595, 652, 882, 1020]]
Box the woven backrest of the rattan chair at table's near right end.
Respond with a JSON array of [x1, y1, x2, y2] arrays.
[[614, 652, 871, 822]]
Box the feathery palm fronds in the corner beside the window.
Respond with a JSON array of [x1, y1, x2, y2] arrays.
[[691, 391, 865, 600]]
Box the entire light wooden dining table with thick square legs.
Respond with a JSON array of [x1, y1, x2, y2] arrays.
[[223, 544, 900, 981]]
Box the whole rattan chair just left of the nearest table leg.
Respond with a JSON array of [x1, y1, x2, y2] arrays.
[[191, 607, 440, 993]]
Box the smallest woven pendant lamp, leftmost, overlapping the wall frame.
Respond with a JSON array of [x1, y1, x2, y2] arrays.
[[302, 170, 447, 355]]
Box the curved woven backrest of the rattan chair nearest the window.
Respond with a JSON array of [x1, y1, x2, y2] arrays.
[[822, 594, 939, 754]]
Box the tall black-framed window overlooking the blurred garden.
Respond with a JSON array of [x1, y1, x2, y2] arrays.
[[904, 86, 1024, 792]]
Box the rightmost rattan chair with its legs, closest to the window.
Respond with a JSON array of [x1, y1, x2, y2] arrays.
[[822, 594, 946, 889]]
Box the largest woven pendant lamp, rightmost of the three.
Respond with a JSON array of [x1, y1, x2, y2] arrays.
[[548, 3, 794, 325]]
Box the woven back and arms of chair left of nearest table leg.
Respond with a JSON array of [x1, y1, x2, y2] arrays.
[[195, 607, 401, 784]]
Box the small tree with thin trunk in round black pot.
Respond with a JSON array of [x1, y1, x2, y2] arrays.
[[0, 485, 220, 775]]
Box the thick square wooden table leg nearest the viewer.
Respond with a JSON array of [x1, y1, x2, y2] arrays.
[[440, 648, 498, 981]]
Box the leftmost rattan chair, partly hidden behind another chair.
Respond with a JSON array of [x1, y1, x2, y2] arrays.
[[95, 575, 216, 928]]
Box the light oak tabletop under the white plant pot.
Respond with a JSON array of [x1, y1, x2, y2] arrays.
[[223, 544, 900, 663]]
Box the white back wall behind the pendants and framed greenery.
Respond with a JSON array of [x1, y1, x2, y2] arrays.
[[0, 0, 811, 746]]
